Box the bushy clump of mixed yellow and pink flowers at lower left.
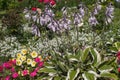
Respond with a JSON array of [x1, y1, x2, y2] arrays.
[[0, 49, 44, 80]]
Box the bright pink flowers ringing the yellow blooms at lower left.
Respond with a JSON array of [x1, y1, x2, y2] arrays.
[[0, 57, 44, 80]]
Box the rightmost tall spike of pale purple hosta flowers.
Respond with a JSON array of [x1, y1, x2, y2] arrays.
[[106, 3, 114, 24]]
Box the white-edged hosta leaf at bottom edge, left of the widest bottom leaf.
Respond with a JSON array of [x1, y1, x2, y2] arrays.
[[66, 69, 80, 80]]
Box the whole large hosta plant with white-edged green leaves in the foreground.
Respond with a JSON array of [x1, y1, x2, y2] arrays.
[[39, 47, 118, 80]]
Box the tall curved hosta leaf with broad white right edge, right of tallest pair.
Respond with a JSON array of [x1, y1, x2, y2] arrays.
[[90, 48, 101, 66]]
